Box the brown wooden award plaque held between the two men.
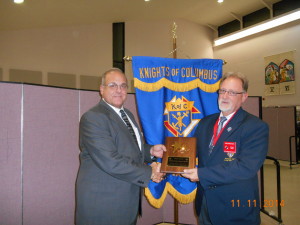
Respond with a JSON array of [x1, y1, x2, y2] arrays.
[[160, 137, 196, 173]]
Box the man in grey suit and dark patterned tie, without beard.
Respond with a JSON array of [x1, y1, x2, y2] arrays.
[[76, 68, 165, 225]]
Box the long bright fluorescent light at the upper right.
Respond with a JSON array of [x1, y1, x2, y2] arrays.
[[214, 10, 300, 46]]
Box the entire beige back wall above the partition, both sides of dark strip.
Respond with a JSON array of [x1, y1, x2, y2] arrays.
[[0, 20, 213, 92]]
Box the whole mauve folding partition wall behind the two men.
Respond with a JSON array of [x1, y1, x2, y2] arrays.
[[0, 82, 260, 225]]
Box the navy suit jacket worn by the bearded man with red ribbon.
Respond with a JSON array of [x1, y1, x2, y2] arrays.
[[195, 108, 269, 225]]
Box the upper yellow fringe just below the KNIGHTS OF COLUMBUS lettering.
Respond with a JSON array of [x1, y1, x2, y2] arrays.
[[134, 78, 220, 92]]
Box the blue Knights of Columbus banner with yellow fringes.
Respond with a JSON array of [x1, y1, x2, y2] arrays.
[[132, 56, 223, 208]]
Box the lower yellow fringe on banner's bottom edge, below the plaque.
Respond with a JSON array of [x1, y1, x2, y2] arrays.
[[145, 183, 197, 209]]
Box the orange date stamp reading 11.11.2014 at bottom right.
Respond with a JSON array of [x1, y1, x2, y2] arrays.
[[231, 199, 285, 208]]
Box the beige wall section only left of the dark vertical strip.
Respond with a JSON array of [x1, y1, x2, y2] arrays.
[[0, 23, 112, 88]]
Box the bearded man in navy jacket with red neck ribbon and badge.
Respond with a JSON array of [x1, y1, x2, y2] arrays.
[[183, 73, 269, 225]]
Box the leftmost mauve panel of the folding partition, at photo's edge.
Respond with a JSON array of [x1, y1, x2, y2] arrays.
[[0, 83, 22, 225]]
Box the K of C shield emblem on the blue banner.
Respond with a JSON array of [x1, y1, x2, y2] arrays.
[[164, 96, 200, 137]]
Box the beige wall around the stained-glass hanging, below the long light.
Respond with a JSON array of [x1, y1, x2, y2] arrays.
[[214, 20, 300, 106]]
